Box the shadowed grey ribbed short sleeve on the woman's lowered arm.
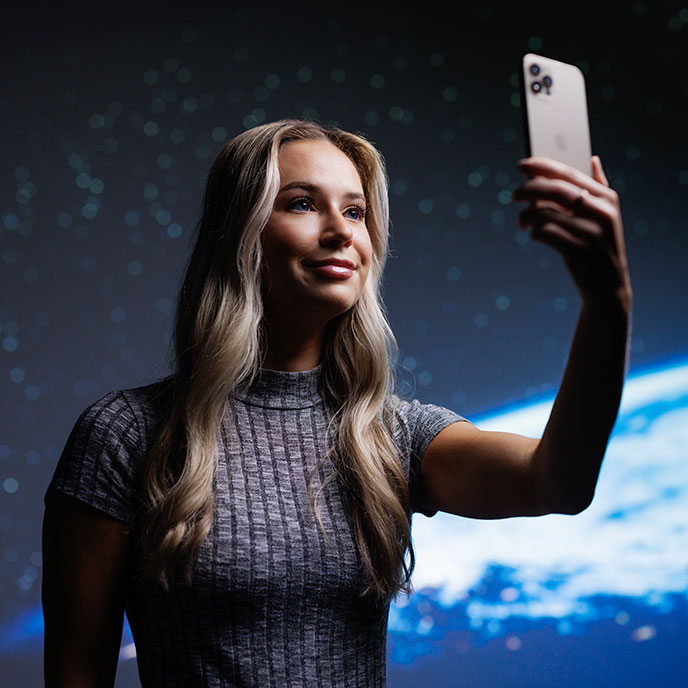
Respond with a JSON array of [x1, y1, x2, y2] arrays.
[[46, 392, 144, 523]]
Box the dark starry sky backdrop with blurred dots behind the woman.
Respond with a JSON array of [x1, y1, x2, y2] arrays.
[[0, 0, 688, 686]]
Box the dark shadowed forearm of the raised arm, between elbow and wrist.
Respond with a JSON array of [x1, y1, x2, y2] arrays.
[[533, 288, 631, 513]]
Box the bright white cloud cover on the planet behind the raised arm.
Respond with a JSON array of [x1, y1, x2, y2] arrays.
[[413, 366, 688, 617]]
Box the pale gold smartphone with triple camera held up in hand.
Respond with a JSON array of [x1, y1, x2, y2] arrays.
[[520, 53, 592, 176]]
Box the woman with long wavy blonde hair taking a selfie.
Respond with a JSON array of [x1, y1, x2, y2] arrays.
[[44, 120, 631, 687]]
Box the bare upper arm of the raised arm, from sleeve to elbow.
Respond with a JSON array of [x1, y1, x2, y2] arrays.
[[420, 423, 550, 518]]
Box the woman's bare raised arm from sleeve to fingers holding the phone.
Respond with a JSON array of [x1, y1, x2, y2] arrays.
[[421, 157, 632, 518]]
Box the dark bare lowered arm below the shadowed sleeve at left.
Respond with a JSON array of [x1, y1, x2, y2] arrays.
[[43, 495, 129, 688]]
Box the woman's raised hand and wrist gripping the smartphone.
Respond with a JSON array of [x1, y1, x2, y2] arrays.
[[513, 156, 632, 309]]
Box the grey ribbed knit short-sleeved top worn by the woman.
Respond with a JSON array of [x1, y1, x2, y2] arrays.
[[48, 368, 460, 688]]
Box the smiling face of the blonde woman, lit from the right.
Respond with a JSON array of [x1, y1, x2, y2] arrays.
[[262, 141, 372, 322]]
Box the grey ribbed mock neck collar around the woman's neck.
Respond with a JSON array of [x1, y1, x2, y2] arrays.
[[234, 366, 322, 409]]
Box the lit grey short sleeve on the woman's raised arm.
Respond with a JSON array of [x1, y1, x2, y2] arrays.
[[392, 397, 467, 516]]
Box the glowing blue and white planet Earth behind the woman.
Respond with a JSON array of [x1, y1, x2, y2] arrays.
[[0, 361, 688, 688]]
